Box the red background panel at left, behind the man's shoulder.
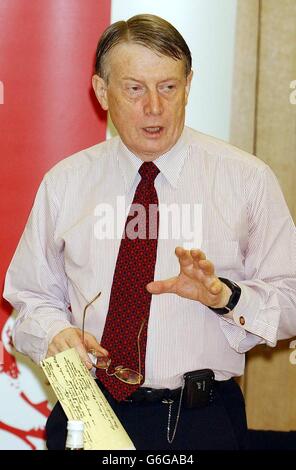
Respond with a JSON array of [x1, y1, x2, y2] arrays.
[[0, 0, 110, 331]]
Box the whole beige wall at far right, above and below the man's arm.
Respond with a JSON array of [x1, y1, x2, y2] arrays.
[[231, 0, 296, 430]]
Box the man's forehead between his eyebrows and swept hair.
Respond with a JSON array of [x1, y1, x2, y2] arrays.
[[106, 43, 185, 80]]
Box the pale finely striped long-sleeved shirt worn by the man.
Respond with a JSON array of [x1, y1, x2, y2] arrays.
[[4, 128, 296, 388]]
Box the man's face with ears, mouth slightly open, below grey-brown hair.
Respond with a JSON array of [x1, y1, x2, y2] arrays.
[[93, 43, 192, 161]]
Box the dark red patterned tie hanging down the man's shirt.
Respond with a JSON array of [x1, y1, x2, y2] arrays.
[[97, 162, 159, 401]]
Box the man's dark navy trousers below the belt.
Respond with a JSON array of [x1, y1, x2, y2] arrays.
[[46, 379, 248, 450]]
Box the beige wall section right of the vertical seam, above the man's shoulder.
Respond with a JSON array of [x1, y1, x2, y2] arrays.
[[255, 0, 296, 220]]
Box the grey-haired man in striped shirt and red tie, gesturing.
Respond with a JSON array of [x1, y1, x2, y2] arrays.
[[5, 15, 296, 449]]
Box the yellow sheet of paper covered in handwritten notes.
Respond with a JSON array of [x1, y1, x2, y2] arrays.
[[41, 349, 135, 450]]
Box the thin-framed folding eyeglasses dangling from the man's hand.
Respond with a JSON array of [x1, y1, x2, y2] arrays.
[[82, 292, 146, 385]]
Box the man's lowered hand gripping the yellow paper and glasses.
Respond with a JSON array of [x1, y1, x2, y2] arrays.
[[46, 328, 109, 369]]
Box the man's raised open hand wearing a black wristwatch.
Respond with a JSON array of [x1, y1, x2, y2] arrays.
[[147, 247, 231, 308]]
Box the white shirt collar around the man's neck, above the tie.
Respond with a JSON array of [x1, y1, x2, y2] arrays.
[[117, 128, 189, 191]]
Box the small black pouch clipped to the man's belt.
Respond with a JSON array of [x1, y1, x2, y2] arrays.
[[183, 369, 215, 408]]
